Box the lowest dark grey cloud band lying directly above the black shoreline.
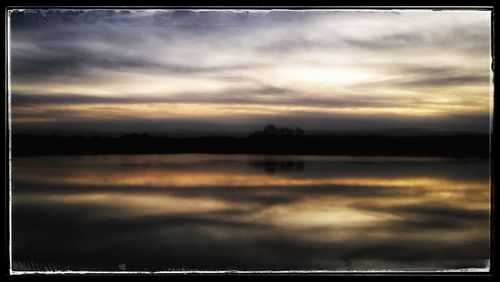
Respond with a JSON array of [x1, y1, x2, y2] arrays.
[[13, 107, 490, 134]]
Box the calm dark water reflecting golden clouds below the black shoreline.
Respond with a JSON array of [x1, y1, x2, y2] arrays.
[[13, 155, 490, 270]]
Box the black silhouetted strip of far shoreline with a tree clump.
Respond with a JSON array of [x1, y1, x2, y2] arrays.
[[12, 125, 489, 158]]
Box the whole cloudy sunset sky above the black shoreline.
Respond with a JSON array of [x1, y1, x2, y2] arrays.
[[9, 10, 493, 133]]
